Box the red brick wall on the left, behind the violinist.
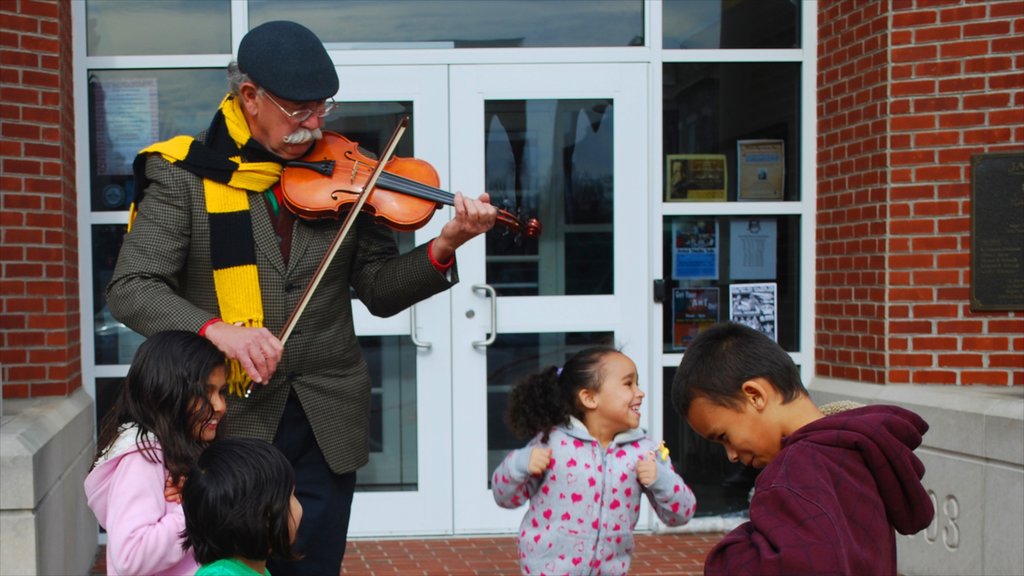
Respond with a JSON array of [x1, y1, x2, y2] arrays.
[[0, 0, 82, 398]]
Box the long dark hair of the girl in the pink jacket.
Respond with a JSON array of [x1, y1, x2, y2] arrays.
[[96, 330, 224, 484]]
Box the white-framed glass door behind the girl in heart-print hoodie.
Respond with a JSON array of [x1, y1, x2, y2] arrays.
[[450, 64, 651, 533]]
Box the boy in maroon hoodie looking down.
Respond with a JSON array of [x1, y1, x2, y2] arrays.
[[672, 323, 934, 575]]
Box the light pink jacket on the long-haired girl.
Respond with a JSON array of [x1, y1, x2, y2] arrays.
[[85, 426, 199, 576]]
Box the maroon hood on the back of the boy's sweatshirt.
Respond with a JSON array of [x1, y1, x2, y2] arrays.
[[782, 406, 934, 534]]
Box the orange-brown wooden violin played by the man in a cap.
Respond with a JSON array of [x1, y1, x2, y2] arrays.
[[281, 131, 541, 238]]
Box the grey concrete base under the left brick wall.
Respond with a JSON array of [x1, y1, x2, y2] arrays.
[[0, 388, 97, 576]]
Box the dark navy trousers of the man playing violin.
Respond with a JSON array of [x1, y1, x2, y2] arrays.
[[267, 392, 355, 576]]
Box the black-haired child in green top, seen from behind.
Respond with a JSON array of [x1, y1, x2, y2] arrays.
[[181, 438, 302, 576]]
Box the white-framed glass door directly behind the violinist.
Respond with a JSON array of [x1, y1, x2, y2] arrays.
[[327, 66, 452, 536]]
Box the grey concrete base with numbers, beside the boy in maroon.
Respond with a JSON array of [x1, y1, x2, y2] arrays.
[[808, 378, 1024, 576]]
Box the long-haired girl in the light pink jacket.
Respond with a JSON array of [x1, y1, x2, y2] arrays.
[[85, 331, 227, 576]]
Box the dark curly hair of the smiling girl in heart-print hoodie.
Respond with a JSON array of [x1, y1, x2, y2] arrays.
[[505, 346, 621, 442]]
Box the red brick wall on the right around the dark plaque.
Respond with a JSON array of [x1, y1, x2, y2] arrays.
[[815, 0, 1024, 385]]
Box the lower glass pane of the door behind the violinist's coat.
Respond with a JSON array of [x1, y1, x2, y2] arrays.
[[356, 336, 418, 492]]
